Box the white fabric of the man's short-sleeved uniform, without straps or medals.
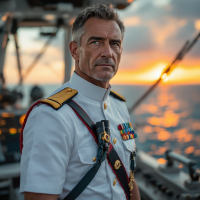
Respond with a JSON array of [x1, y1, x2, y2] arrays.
[[20, 73, 135, 200]]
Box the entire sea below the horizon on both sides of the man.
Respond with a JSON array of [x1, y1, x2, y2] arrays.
[[9, 85, 200, 171]]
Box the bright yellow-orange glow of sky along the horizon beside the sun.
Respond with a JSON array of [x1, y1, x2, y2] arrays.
[[112, 63, 200, 84]]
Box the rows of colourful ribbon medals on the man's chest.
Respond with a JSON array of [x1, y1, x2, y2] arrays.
[[118, 122, 137, 140]]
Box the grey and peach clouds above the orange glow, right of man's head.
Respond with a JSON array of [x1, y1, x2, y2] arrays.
[[120, 0, 200, 57]]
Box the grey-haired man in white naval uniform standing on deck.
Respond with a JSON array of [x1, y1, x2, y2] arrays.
[[20, 5, 140, 200]]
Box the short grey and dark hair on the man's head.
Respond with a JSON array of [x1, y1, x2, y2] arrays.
[[72, 4, 125, 46]]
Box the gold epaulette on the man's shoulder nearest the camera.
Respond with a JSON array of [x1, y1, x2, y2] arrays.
[[41, 87, 78, 110]]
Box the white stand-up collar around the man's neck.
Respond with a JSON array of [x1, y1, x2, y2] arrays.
[[69, 72, 111, 101]]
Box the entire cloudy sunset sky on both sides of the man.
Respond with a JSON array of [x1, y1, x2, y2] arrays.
[[4, 0, 200, 84]]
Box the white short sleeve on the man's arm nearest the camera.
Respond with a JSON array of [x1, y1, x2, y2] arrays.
[[20, 105, 73, 194]]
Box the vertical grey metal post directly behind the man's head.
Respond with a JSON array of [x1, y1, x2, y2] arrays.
[[64, 26, 72, 82]]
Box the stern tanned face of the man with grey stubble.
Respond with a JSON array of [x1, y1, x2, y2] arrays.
[[78, 18, 122, 81]]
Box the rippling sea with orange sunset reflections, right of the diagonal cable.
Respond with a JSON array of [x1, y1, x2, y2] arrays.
[[134, 86, 200, 168]]
